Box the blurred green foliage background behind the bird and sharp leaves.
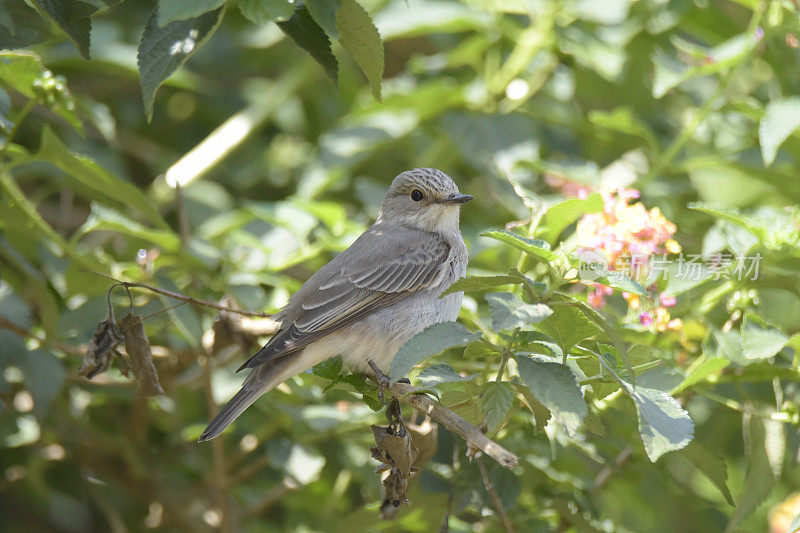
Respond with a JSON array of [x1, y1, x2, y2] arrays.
[[0, 0, 800, 532]]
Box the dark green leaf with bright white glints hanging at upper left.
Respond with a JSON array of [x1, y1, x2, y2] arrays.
[[137, 7, 225, 122]]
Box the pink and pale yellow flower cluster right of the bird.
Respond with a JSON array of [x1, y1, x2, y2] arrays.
[[564, 185, 683, 331]]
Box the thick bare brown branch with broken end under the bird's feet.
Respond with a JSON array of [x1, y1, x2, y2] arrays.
[[389, 382, 519, 470]]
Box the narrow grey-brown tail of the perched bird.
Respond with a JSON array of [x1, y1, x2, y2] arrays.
[[197, 357, 293, 442]]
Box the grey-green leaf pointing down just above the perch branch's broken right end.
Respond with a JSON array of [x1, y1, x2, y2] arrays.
[[516, 356, 587, 436]]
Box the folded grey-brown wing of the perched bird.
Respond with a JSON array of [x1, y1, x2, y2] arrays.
[[241, 230, 450, 368]]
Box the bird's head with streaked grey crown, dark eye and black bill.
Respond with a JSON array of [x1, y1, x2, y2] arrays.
[[378, 168, 472, 232]]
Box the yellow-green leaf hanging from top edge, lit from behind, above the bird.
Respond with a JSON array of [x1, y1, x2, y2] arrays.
[[336, 0, 384, 101]]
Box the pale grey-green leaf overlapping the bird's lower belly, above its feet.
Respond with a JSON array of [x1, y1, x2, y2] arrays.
[[389, 322, 481, 381]]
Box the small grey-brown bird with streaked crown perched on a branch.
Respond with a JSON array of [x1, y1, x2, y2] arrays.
[[198, 168, 473, 442]]
